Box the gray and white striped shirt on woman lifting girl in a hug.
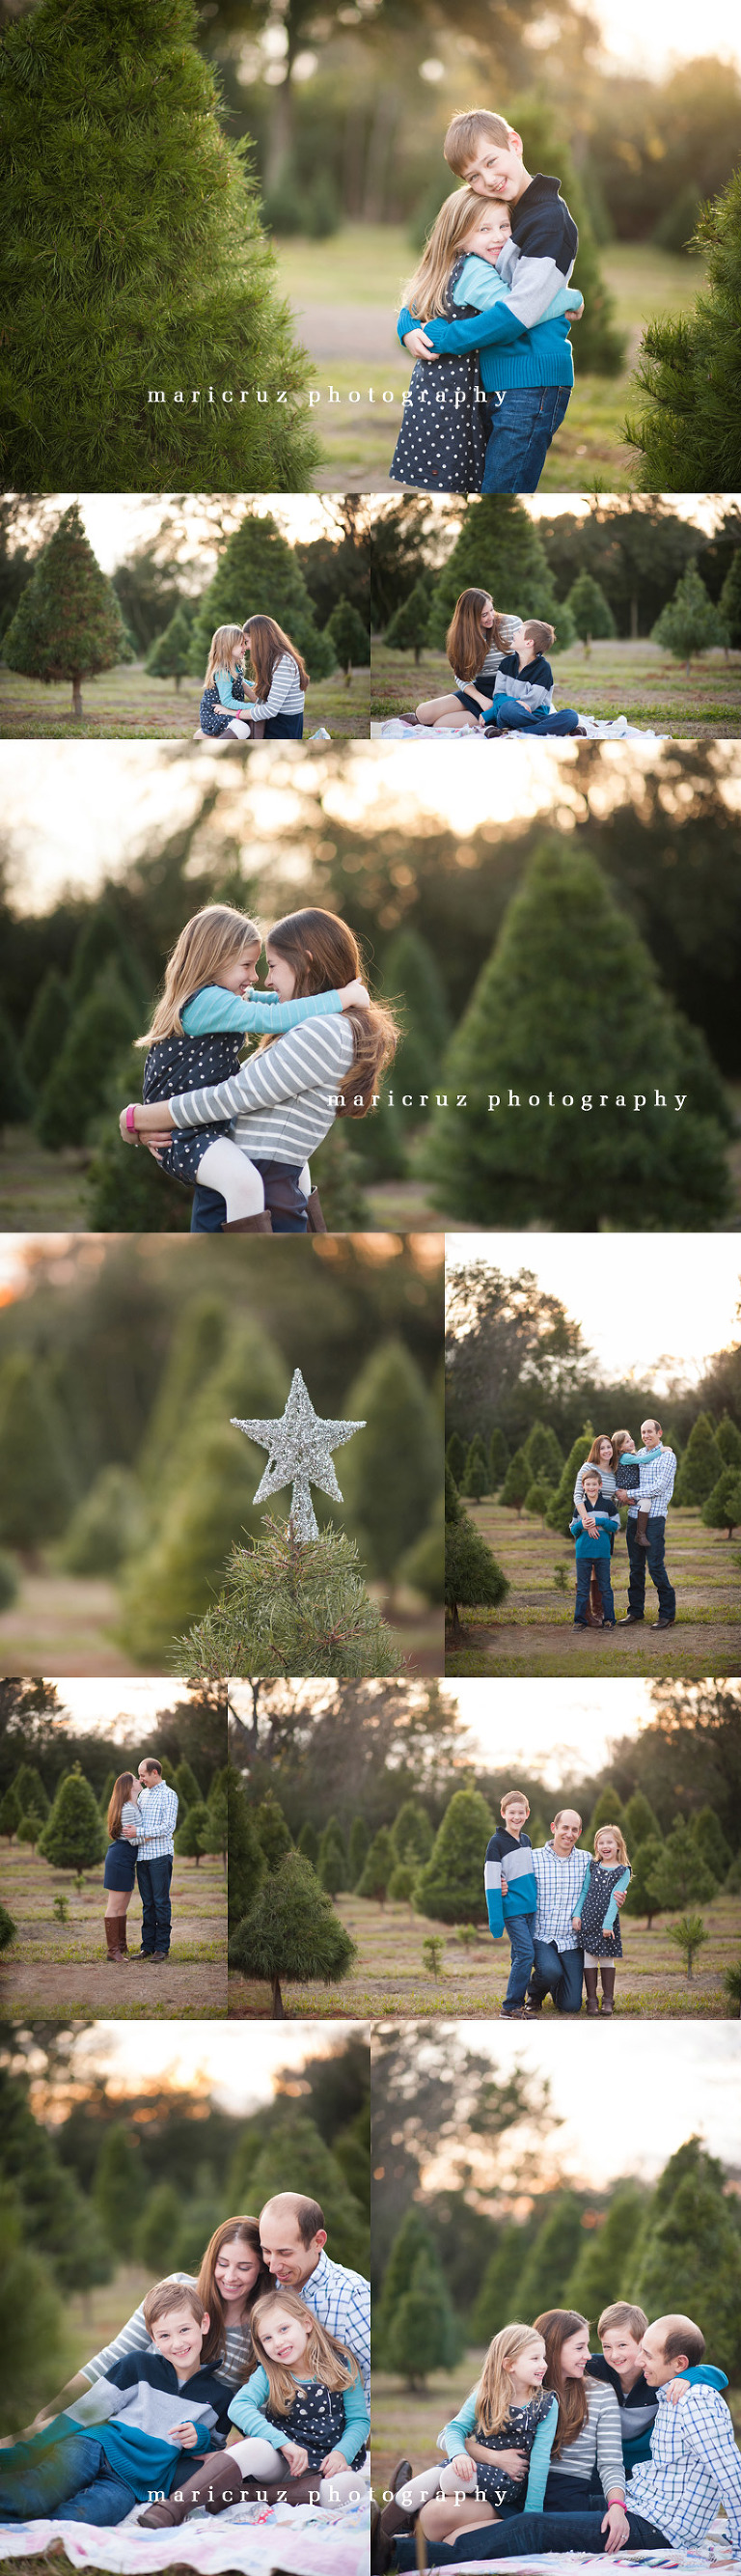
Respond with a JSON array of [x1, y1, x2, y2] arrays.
[[170, 1015, 355, 1164]]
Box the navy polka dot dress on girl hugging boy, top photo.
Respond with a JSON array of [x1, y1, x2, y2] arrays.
[[389, 255, 489, 492]]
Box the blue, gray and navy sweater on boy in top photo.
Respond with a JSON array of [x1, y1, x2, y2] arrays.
[[397, 170, 579, 394]]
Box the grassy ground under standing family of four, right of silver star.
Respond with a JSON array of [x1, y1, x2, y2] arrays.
[[445, 1499, 741, 1682]]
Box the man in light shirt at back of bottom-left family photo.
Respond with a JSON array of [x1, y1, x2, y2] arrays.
[[260, 2192, 370, 2398]]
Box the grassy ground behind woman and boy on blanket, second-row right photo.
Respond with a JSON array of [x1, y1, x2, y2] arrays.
[[370, 636, 741, 742]]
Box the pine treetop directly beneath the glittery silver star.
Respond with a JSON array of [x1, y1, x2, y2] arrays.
[[173, 1514, 398, 1682]]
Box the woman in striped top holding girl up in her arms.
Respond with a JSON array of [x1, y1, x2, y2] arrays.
[[119, 904, 398, 1233]]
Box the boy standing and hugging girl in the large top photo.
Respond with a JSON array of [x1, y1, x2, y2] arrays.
[[398, 108, 579, 492]]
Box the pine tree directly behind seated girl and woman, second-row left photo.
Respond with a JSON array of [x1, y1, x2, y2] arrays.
[[190, 507, 335, 680]]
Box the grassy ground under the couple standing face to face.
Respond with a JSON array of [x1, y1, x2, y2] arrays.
[[0, 1842, 227, 2022]]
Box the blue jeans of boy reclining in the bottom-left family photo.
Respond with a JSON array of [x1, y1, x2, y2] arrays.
[[0, 2432, 136, 2525]]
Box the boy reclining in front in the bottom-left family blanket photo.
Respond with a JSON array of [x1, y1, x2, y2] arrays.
[[0, 2280, 232, 2525]]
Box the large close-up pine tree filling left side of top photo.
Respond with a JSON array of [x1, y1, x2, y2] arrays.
[[3, 0, 316, 492]]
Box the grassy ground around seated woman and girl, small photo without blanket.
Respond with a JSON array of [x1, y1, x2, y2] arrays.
[[0, 662, 370, 758]]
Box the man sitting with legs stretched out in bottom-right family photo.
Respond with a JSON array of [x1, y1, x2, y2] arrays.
[[380, 2315, 741, 2576]]
